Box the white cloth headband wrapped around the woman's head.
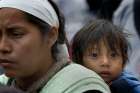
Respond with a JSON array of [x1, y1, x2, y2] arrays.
[[0, 0, 59, 27]]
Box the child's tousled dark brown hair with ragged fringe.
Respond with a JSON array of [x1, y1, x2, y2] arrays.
[[71, 20, 129, 64]]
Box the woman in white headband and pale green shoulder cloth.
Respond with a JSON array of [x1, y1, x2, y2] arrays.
[[0, 0, 110, 93]]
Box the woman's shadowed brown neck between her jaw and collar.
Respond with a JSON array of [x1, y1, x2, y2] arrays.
[[15, 57, 55, 91]]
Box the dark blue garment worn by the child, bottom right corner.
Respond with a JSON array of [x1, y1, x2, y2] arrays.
[[110, 72, 140, 93]]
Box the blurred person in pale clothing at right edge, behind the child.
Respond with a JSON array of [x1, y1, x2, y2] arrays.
[[112, 0, 140, 79]]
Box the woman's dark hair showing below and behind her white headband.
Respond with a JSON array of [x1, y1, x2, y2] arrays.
[[25, 0, 68, 58]]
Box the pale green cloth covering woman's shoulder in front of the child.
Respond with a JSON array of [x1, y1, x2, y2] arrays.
[[41, 64, 110, 93]]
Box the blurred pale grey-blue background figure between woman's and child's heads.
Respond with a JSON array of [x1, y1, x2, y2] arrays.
[[54, 0, 96, 41]]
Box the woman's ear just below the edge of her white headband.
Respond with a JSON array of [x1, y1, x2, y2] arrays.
[[46, 27, 58, 46]]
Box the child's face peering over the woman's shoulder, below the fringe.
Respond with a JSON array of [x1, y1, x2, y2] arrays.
[[83, 42, 123, 84]]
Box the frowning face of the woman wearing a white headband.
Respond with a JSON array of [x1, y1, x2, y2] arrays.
[[0, 8, 53, 78]]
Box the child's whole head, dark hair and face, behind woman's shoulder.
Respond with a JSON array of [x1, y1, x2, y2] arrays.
[[71, 20, 129, 85]]
